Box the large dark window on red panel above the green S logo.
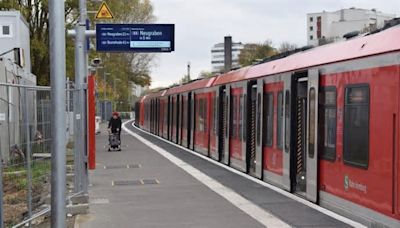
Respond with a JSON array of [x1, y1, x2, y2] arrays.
[[343, 84, 369, 168]]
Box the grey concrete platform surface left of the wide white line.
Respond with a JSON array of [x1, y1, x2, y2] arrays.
[[75, 124, 263, 228]]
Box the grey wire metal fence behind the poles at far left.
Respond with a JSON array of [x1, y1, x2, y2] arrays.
[[0, 83, 74, 227]]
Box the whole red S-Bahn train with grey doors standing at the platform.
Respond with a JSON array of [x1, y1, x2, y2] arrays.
[[136, 22, 400, 227]]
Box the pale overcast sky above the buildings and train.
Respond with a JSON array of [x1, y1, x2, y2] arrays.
[[151, 0, 400, 88]]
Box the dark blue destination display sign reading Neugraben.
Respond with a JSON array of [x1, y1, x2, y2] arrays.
[[96, 24, 175, 52]]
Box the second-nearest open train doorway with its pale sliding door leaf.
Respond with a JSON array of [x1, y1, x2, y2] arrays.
[[247, 81, 262, 178]]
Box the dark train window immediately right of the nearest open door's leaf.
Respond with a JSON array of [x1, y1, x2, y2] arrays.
[[318, 86, 336, 161]]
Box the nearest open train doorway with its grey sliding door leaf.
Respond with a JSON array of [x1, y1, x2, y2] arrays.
[[289, 70, 319, 202]]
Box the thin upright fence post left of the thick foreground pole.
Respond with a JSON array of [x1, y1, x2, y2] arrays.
[[22, 88, 32, 227]]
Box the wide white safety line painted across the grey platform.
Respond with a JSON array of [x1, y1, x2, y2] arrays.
[[122, 122, 291, 228]]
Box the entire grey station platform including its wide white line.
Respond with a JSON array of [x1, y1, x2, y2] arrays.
[[75, 122, 357, 228]]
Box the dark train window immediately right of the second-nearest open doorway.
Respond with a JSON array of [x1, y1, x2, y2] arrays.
[[263, 93, 274, 147]]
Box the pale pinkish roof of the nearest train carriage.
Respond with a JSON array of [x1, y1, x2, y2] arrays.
[[213, 26, 400, 85]]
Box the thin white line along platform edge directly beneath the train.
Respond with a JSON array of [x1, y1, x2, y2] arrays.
[[124, 120, 367, 228]]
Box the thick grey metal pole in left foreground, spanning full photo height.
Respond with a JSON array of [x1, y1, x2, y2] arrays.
[[49, 0, 66, 228]]
